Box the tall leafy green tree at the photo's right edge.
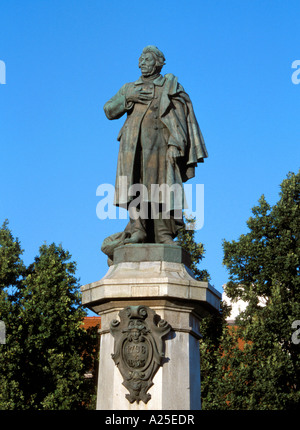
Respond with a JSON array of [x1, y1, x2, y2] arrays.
[[216, 172, 300, 409]]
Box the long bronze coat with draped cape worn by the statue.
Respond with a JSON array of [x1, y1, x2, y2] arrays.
[[104, 74, 208, 209]]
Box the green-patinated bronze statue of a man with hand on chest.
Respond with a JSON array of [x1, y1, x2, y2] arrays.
[[104, 45, 207, 256]]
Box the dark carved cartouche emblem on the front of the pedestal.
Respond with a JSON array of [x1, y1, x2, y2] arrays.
[[110, 306, 171, 403]]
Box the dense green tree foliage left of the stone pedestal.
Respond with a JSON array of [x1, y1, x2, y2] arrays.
[[0, 224, 97, 410]]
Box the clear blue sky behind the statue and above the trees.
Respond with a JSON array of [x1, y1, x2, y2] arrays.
[[0, 0, 300, 316]]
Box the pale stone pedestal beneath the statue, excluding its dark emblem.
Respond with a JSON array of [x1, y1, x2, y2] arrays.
[[81, 244, 221, 410]]
